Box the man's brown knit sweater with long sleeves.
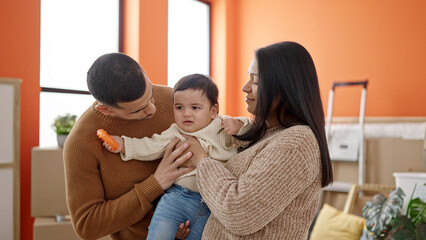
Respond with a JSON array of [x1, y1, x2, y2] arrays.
[[64, 86, 174, 240]]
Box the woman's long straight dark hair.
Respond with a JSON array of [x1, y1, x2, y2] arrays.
[[237, 42, 333, 187]]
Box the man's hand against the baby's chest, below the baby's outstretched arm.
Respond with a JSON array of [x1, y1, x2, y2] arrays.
[[154, 138, 194, 190]]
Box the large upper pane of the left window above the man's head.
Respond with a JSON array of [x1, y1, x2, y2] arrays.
[[40, 0, 119, 90]]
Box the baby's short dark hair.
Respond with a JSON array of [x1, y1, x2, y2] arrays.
[[172, 74, 219, 106]]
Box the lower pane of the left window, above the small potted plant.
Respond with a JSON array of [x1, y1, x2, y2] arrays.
[[40, 92, 96, 147]]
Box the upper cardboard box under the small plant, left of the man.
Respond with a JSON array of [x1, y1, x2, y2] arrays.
[[31, 147, 69, 217]]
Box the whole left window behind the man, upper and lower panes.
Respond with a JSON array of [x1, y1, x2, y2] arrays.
[[40, 0, 120, 147]]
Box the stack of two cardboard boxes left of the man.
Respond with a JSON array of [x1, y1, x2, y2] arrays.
[[31, 147, 109, 240]]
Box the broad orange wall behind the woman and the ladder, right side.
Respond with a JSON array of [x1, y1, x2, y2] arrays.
[[212, 0, 426, 116]]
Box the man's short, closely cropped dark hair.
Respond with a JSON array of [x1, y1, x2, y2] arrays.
[[87, 53, 146, 107]]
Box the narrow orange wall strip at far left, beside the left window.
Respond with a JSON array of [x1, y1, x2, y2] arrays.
[[0, 0, 40, 240]]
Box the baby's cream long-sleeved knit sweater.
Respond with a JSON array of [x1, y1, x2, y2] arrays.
[[121, 115, 251, 192]]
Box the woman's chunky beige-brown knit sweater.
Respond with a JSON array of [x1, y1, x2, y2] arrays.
[[197, 126, 321, 240]]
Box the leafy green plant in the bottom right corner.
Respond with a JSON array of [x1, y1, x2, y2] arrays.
[[361, 187, 426, 240]]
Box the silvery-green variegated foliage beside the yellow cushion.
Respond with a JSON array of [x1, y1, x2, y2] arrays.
[[362, 188, 405, 237]]
